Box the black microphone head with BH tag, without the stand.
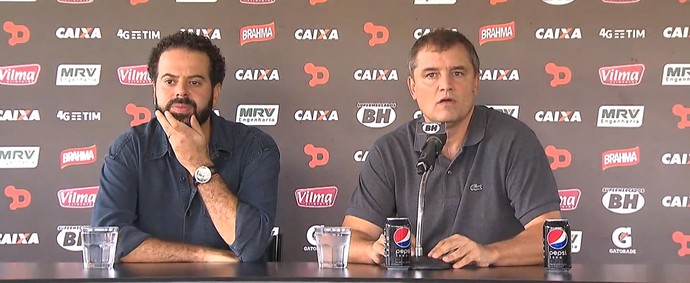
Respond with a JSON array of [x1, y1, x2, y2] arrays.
[[417, 122, 448, 175]]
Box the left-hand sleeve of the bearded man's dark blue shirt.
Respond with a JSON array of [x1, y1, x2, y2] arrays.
[[91, 133, 150, 261]]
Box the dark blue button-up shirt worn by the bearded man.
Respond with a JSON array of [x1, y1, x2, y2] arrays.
[[91, 114, 280, 261]]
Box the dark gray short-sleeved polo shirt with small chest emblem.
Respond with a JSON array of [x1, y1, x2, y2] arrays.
[[346, 106, 560, 251]]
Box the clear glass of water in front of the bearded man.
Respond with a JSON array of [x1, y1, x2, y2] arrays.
[[81, 227, 119, 269]]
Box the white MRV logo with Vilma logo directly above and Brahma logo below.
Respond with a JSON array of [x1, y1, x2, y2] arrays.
[[597, 105, 644, 128]]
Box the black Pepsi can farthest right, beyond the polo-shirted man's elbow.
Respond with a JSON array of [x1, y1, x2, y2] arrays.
[[544, 219, 572, 270]]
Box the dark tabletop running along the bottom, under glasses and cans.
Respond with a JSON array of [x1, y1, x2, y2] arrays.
[[0, 262, 690, 283]]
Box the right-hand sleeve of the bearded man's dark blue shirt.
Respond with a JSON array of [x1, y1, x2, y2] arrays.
[[230, 145, 280, 262]]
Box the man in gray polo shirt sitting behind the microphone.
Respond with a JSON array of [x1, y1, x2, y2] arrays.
[[343, 30, 561, 268]]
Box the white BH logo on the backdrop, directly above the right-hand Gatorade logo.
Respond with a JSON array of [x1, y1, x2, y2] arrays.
[[601, 188, 645, 214]]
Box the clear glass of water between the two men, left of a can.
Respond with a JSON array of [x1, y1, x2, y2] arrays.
[[314, 226, 350, 268]]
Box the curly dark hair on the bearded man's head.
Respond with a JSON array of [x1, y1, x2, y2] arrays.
[[148, 31, 225, 86]]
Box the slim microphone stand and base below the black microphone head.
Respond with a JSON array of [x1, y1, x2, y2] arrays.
[[410, 164, 452, 270]]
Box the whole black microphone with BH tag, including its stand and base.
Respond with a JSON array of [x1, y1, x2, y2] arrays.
[[410, 122, 452, 270]]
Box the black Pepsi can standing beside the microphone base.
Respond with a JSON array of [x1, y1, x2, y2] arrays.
[[383, 218, 412, 269]]
